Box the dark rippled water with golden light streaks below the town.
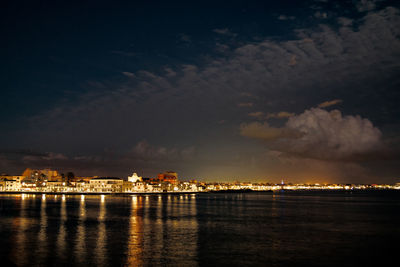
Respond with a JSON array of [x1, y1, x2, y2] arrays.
[[0, 191, 400, 266]]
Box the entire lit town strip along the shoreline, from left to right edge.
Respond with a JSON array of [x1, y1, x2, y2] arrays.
[[0, 168, 400, 194]]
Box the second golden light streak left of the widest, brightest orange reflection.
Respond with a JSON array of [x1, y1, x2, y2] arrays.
[[75, 195, 86, 264]]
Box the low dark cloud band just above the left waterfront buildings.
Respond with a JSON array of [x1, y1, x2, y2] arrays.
[[0, 140, 197, 177]]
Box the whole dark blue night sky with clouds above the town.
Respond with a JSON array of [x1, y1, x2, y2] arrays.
[[0, 0, 400, 183]]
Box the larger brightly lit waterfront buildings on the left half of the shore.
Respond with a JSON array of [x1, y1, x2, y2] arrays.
[[0, 168, 202, 193]]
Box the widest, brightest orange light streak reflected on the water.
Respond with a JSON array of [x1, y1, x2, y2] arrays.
[[126, 196, 143, 266]]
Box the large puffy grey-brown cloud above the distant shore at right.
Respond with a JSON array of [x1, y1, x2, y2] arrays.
[[240, 108, 383, 160]]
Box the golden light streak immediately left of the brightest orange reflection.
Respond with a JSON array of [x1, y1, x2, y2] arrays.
[[95, 195, 107, 266]]
